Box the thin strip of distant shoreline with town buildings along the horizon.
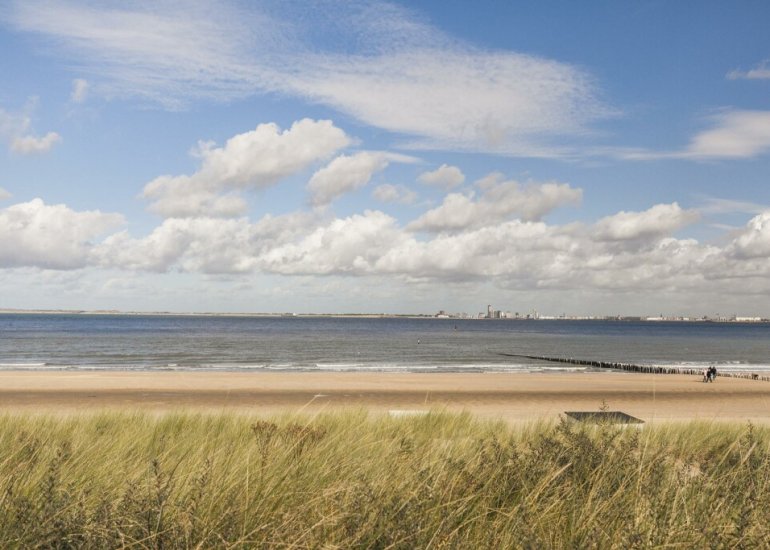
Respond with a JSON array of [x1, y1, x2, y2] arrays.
[[0, 308, 770, 324]]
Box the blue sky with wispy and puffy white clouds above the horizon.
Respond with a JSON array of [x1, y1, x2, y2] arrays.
[[0, 0, 770, 317]]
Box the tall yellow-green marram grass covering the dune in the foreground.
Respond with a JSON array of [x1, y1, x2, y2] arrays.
[[0, 411, 770, 548]]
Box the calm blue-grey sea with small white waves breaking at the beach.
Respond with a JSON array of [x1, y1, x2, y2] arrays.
[[0, 314, 770, 372]]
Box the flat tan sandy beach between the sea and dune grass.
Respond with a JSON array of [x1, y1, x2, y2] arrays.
[[0, 371, 770, 423]]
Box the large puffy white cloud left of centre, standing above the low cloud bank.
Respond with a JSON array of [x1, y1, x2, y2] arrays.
[[143, 119, 350, 217]]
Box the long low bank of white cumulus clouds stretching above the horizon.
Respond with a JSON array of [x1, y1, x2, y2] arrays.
[[0, 189, 770, 302]]
